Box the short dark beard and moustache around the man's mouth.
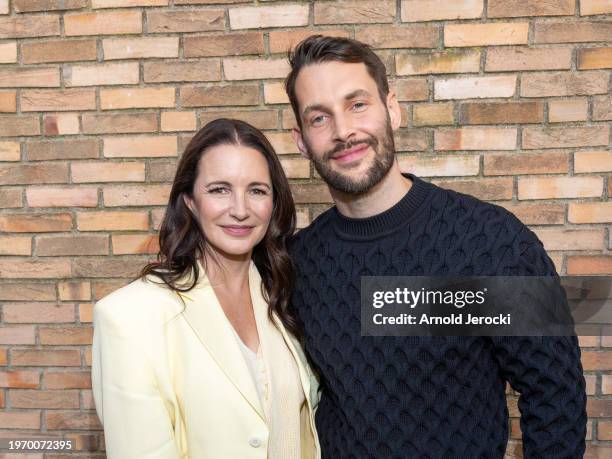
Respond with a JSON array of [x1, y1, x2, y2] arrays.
[[304, 115, 395, 195]]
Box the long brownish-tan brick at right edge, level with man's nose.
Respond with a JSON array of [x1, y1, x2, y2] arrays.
[[523, 126, 608, 150]]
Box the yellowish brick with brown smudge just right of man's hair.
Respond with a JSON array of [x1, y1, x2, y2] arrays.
[[395, 50, 480, 75]]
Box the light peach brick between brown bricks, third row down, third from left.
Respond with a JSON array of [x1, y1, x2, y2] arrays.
[[102, 37, 179, 61]]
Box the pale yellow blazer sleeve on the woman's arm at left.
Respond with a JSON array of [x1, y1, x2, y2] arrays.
[[92, 303, 182, 459]]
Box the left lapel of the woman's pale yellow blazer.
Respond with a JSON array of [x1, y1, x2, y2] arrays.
[[181, 265, 265, 420]]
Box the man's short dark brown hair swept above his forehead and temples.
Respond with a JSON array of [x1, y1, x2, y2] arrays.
[[285, 35, 389, 129]]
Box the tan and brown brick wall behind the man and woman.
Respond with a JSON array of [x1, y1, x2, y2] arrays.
[[0, 0, 612, 458]]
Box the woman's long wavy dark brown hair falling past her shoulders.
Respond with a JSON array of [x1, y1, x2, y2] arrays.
[[141, 118, 300, 337]]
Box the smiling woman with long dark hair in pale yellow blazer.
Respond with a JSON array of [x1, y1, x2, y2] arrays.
[[92, 119, 320, 459]]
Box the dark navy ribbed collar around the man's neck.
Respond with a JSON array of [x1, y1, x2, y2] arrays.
[[331, 174, 433, 240]]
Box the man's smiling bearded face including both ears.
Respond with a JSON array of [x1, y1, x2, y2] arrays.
[[294, 61, 400, 195]]
